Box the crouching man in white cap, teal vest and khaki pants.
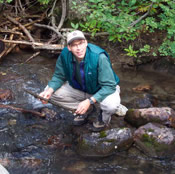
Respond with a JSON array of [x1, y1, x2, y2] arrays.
[[40, 30, 127, 131]]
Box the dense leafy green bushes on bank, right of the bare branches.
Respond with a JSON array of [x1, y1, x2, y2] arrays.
[[72, 0, 175, 58]]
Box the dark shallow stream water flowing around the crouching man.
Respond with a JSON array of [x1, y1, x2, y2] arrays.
[[0, 52, 175, 174]]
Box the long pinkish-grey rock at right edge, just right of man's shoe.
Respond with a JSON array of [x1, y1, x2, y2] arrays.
[[125, 107, 175, 128]]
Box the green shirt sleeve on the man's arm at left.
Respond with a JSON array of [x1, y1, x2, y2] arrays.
[[48, 56, 66, 91]]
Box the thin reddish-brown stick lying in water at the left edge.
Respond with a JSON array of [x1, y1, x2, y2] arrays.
[[0, 104, 45, 117]]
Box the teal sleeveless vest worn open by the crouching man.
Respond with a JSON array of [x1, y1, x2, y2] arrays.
[[61, 43, 120, 94]]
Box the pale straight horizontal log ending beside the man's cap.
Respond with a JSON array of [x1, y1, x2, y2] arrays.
[[1, 39, 64, 50]]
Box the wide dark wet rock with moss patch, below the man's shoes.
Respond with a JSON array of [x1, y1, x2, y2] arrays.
[[77, 128, 133, 157]]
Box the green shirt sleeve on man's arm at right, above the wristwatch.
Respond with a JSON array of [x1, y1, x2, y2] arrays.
[[93, 54, 117, 102]]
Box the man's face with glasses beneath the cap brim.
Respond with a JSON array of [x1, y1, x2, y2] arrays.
[[68, 40, 87, 60]]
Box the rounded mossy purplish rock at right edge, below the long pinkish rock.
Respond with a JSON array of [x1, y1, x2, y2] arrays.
[[134, 123, 175, 158]]
